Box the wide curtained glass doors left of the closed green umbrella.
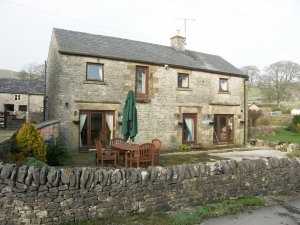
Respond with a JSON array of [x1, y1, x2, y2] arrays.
[[79, 110, 114, 151]]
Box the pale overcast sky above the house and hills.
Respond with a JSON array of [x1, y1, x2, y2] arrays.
[[0, 0, 300, 71]]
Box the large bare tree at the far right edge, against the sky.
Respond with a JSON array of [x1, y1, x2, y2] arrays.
[[260, 61, 300, 107]]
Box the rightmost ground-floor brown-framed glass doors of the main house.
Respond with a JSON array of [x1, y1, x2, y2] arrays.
[[214, 114, 234, 144]]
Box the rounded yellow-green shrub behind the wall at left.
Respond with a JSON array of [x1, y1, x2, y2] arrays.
[[16, 123, 47, 162]]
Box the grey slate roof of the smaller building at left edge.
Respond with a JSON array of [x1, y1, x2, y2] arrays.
[[0, 78, 45, 94]]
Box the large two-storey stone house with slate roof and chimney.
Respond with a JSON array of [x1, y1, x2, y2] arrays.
[[46, 29, 247, 151]]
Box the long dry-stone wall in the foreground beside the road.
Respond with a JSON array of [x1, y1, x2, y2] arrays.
[[0, 158, 300, 224]]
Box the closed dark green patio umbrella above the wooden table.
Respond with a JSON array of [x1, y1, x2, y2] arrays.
[[122, 90, 138, 142]]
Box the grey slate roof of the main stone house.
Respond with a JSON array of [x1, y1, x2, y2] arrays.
[[53, 28, 247, 78]]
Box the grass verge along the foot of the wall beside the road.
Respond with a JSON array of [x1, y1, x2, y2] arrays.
[[61, 196, 265, 225]]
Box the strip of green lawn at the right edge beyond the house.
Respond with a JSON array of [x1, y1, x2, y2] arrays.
[[256, 130, 300, 144]]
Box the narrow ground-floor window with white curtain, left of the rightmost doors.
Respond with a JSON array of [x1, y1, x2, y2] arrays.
[[182, 114, 197, 144]]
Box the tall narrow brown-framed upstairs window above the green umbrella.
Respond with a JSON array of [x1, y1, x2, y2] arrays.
[[135, 66, 148, 98]]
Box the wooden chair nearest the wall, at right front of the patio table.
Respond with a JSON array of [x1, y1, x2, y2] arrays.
[[135, 143, 154, 167]]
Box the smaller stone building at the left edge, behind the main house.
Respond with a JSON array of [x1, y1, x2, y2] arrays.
[[0, 78, 45, 122]]
